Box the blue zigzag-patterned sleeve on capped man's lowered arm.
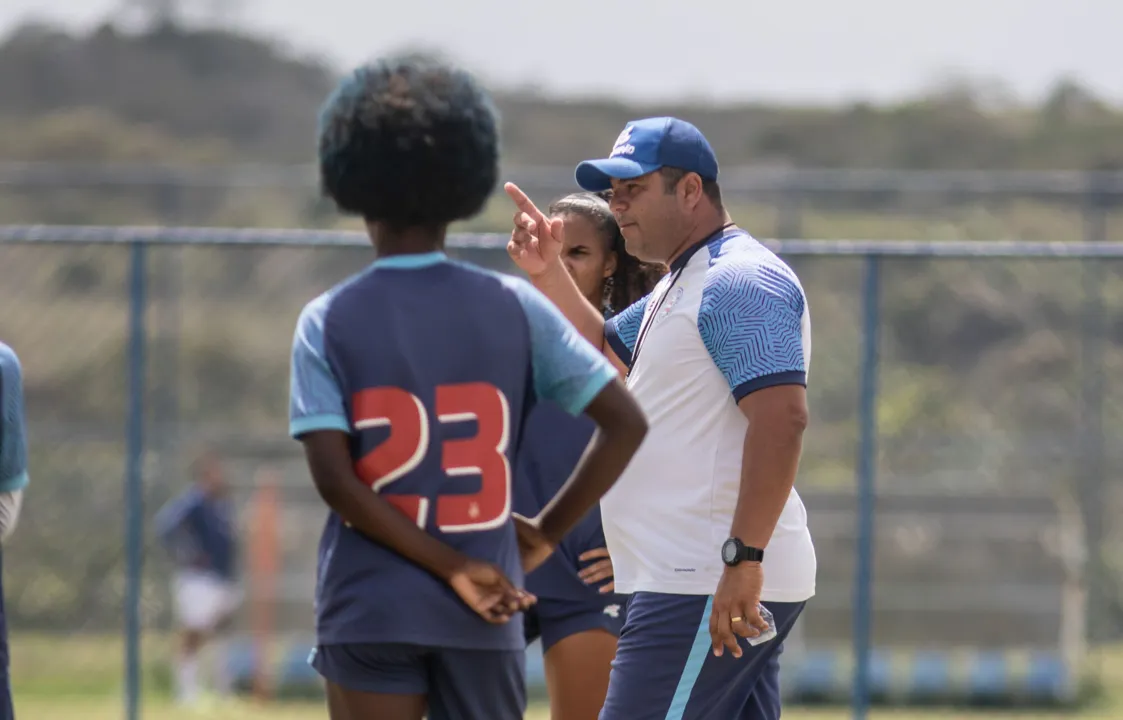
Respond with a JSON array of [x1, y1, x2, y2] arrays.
[[699, 258, 810, 401]]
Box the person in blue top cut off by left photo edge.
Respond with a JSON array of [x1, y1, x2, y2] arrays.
[[0, 343, 29, 720]]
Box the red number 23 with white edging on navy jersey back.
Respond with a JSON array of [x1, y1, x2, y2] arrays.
[[351, 383, 511, 532]]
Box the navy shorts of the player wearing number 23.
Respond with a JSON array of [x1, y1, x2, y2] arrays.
[[310, 642, 527, 720]]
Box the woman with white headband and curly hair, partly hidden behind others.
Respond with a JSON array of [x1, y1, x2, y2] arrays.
[[514, 192, 666, 720]]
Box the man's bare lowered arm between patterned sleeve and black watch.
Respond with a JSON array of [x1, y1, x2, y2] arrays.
[[731, 419, 804, 549]]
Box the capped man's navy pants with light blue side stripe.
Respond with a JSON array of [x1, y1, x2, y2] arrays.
[[600, 592, 805, 720]]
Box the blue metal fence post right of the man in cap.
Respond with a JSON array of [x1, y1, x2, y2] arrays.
[[851, 255, 882, 720]]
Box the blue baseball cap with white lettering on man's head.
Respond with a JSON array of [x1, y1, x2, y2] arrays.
[[574, 118, 718, 192]]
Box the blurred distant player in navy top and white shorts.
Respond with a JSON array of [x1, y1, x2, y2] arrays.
[[155, 450, 243, 704]]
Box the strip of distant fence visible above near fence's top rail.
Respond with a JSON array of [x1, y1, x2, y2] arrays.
[[0, 163, 1123, 241]]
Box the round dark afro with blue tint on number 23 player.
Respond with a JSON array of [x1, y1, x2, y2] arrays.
[[319, 54, 499, 228]]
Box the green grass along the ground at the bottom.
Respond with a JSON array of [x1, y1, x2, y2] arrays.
[[11, 634, 1123, 720]]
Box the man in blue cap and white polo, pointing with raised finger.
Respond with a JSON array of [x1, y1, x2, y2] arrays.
[[506, 118, 815, 720]]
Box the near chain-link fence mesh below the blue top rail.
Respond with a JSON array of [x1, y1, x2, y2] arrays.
[[0, 227, 1123, 698]]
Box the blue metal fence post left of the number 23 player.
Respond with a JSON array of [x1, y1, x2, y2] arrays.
[[125, 241, 148, 720]]
